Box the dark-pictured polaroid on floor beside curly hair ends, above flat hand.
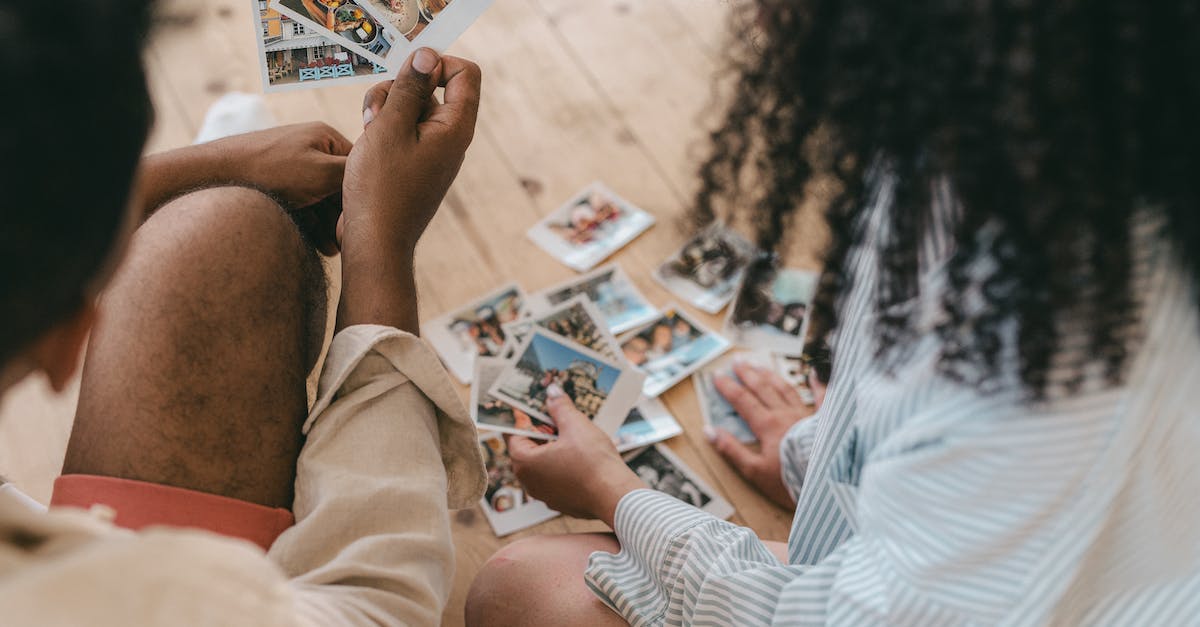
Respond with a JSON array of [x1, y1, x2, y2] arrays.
[[721, 264, 821, 354]]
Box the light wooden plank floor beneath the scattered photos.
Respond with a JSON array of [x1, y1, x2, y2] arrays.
[[0, 0, 812, 625]]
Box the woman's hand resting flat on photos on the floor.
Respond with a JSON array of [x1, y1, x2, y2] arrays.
[[706, 364, 824, 509]]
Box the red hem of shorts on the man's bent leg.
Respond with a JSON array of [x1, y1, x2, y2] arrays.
[[50, 474, 295, 550]]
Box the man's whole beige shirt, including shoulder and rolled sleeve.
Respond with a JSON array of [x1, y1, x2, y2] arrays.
[[0, 326, 486, 627]]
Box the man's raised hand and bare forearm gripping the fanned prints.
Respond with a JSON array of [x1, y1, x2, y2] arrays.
[[337, 48, 480, 333]]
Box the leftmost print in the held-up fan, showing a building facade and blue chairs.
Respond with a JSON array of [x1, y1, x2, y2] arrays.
[[252, 1, 388, 92]]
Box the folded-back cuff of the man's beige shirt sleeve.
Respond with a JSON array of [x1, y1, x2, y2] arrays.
[[302, 324, 487, 509]]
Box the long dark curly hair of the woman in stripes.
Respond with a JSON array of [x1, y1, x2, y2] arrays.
[[694, 0, 1200, 396]]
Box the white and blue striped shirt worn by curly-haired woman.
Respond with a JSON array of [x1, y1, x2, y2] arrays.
[[586, 183, 1200, 627]]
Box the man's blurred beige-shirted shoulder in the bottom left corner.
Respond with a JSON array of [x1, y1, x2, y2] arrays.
[[0, 518, 293, 627]]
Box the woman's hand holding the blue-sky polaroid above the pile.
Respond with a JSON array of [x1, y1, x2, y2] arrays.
[[509, 393, 646, 527]]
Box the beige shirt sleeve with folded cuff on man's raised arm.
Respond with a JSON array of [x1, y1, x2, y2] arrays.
[[269, 326, 486, 626]]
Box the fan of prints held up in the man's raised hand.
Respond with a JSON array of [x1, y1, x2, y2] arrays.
[[252, 0, 493, 91]]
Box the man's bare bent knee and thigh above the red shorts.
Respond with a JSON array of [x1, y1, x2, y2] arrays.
[[62, 187, 326, 508]]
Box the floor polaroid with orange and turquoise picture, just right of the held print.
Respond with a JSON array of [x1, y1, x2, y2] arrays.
[[620, 306, 730, 399]]
